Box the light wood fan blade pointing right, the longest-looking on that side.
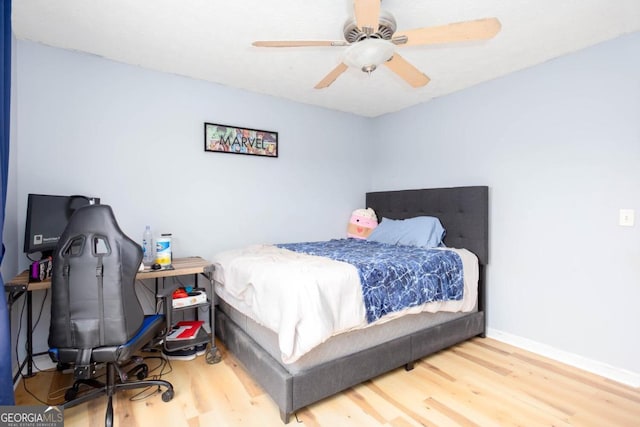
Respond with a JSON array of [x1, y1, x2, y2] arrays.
[[393, 18, 502, 46]]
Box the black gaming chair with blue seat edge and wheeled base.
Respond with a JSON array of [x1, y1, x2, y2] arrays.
[[49, 205, 173, 426]]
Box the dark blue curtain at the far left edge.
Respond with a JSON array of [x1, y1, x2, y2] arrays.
[[0, 0, 15, 405]]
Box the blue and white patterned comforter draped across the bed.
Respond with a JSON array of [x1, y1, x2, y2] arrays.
[[276, 239, 464, 323]]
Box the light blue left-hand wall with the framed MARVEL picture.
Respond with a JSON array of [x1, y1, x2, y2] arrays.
[[5, 41, 370, 358]]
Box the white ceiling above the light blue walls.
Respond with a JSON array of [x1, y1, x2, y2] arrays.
[[13, 0, 640, 117]]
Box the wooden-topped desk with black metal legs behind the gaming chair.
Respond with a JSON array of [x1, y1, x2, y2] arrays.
[[4, 257, 219, 383]]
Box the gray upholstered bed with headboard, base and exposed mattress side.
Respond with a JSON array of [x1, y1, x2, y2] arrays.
[[214, 186, 488, 423]]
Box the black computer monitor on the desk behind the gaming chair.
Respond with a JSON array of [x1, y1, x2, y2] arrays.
[[24, 194, 100, 259]]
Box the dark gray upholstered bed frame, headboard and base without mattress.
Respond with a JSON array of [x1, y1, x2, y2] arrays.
[[215, 187, 488, 424]]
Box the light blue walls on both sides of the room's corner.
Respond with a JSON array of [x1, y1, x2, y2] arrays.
[[3, 34, 640, 382]]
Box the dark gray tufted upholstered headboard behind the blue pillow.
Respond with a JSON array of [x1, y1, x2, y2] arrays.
[[366, 186, 489, 265]]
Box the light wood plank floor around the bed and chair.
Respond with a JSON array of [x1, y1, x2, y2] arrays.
[[16, 338, 640, 427]]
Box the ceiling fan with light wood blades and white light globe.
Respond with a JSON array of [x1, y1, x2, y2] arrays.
[[253, 0, 501, 89]]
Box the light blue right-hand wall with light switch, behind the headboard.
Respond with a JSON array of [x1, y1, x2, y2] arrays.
[[372, 34, 640, 374]]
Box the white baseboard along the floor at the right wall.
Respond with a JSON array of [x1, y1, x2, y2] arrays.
[[487, 328, 640, 388]]
